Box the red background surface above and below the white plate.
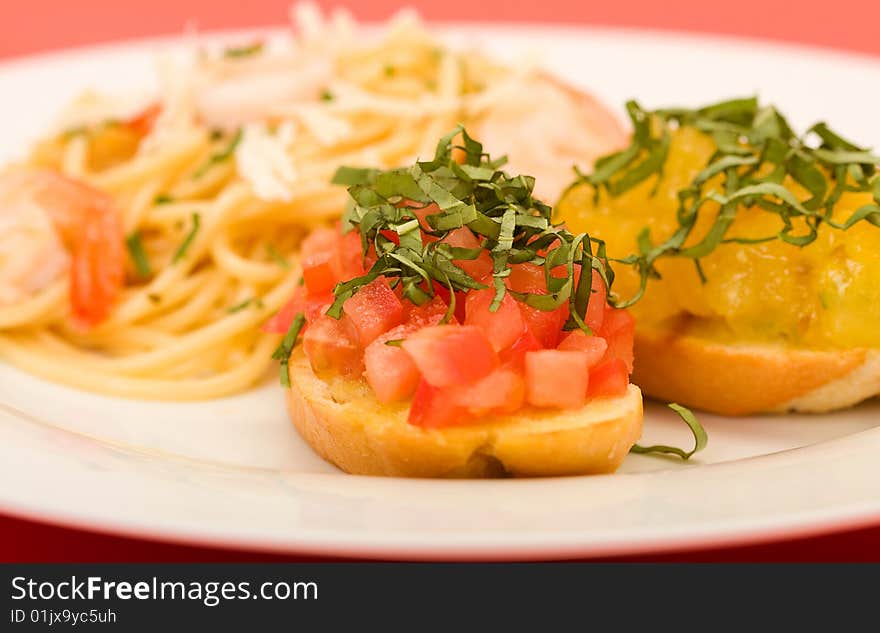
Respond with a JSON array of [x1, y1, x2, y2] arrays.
[[0, 0, 880, 562]]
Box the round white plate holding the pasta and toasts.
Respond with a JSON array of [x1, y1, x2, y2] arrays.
[[0, 25, 880, 559]]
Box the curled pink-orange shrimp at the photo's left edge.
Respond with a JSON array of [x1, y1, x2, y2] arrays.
[[0, 169, 125, 329]]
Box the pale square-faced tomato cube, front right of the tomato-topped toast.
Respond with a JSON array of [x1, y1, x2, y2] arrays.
[[525, 349, 590, 409]]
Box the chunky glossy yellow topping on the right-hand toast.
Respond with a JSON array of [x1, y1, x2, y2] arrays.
[[557, 128, 880, 349]]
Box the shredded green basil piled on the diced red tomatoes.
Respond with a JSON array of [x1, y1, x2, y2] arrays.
[[327, 126, 614, 333]]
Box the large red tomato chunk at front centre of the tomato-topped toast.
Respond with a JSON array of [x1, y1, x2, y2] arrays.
[[403, 325, 498, 387]]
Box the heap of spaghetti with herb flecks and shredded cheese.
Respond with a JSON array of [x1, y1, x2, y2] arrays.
[[0, 5, 624, 400]]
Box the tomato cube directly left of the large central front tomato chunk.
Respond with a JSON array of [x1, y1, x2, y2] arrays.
[[364, 325, 421, 402]]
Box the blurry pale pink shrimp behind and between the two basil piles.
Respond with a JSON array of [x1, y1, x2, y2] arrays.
[[468, 72, 629, 204]]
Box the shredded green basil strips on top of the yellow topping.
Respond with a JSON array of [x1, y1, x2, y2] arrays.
[[572, 97, 880, 307]]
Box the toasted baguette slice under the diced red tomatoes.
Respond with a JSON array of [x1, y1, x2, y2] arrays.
[[287, 349, 642, 477]]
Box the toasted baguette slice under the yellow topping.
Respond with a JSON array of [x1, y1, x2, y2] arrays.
[[633, 327, 880, 415]]
